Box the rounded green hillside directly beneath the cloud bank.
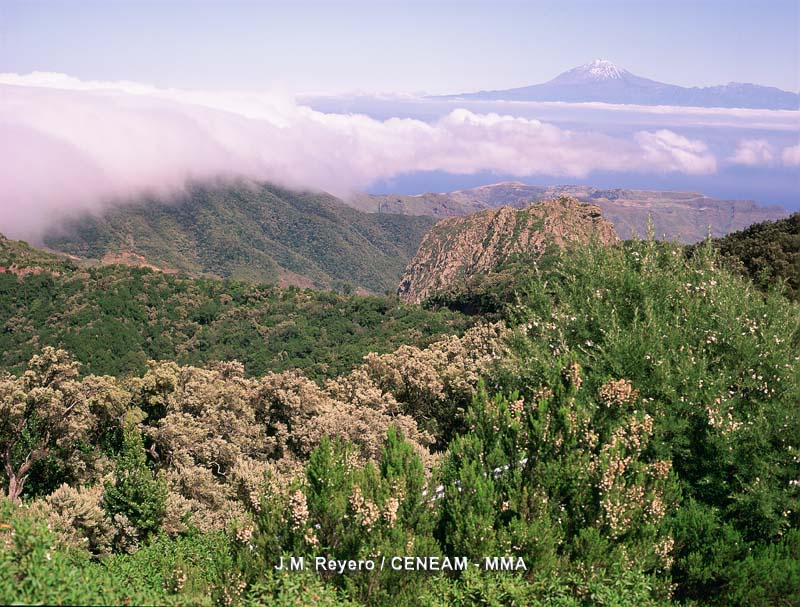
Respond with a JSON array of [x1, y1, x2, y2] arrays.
[[44, 183, 433, 293]]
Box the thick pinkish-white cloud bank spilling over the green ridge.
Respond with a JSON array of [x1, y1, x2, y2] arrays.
[[0, 73, 717, 239]]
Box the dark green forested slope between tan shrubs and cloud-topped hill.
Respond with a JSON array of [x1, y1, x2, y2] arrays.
[[0, 234, 468, 379]]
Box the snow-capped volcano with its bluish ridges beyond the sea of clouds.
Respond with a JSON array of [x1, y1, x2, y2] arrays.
[[440, 59, 800, 110]]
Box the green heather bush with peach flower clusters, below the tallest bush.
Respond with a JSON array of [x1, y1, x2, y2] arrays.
[[440, 384, 677, 602]]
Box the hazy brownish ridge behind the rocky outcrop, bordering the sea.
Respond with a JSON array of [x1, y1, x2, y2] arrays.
[[347, 181, 788, 243]]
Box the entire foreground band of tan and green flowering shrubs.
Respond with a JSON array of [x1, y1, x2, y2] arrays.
[[0, 234, 800, 607]]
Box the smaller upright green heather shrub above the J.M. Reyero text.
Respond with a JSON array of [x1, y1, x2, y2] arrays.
[[241, 429, 441, 605]]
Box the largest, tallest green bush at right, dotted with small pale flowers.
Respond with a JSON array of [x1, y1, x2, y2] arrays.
[[495, 241, 800, 603]]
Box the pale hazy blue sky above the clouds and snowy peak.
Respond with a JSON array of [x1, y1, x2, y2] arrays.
[[0, 0, 800, 93]]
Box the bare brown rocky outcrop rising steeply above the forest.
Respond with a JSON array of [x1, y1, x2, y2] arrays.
[[398, 197, 619, 303]]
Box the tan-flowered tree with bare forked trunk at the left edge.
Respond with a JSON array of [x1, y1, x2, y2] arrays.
[[0, 347, 94, 503]]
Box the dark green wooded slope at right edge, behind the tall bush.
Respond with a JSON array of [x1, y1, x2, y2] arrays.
[[700, 213, 800, 300]]
